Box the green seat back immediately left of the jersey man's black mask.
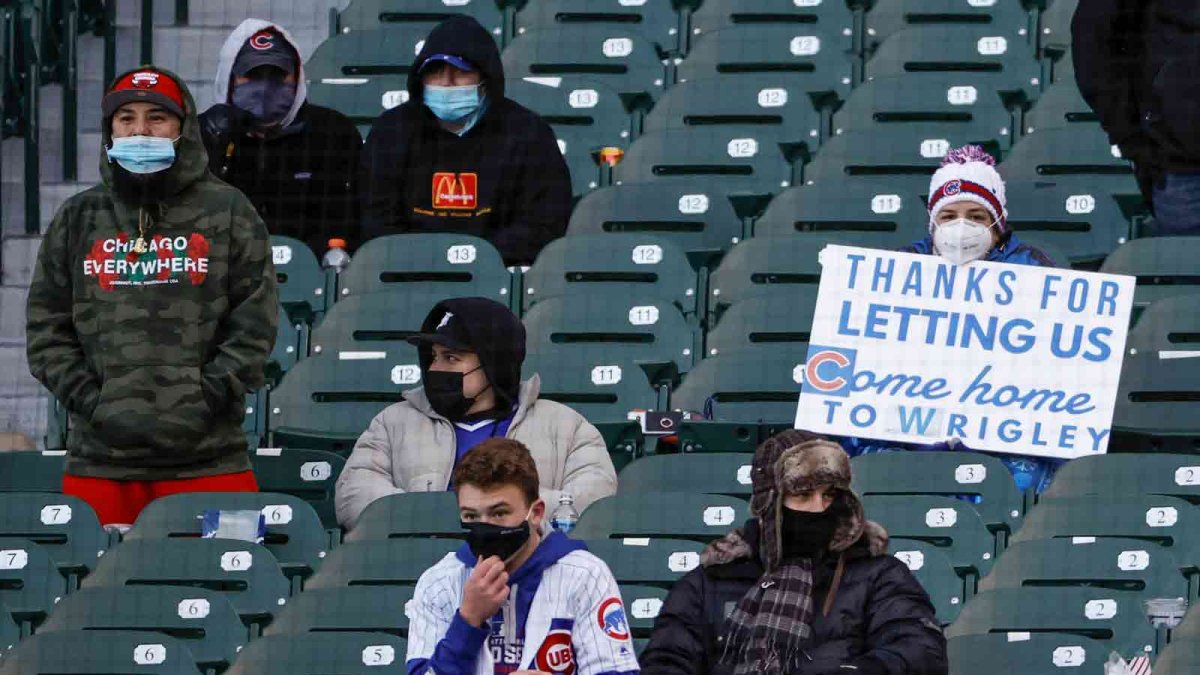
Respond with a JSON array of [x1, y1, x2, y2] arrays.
[[305, 538, 462, 592]]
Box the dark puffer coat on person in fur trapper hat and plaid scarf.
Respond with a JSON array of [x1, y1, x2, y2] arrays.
[[638, 520, 948, 675]]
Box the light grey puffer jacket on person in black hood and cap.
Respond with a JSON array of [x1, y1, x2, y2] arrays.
[[337, 375, 617, 528]]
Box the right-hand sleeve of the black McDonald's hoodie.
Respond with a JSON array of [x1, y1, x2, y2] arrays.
[[492, 119, 571, 265]]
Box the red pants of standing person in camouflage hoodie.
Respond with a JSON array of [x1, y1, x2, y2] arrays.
[[62, 471, 258, 526]]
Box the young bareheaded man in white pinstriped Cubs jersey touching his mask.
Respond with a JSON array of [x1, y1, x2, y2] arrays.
[[406, 438, 640, 675]]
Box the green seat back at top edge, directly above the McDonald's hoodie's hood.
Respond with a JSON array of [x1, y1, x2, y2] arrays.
[[337, 0, 504, 38]]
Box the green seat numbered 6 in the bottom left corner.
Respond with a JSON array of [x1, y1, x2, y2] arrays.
[[0, 631, 199, 675]]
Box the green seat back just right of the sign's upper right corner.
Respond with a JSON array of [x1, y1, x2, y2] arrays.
[[1100, 237, 1200, 315]]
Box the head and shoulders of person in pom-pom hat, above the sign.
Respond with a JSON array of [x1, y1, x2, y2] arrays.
[[901, 145, 1066, 267]]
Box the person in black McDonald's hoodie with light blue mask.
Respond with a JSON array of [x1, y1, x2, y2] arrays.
[[361, 17, 571, 264]]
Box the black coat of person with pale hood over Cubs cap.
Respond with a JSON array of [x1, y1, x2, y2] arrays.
[[204, 103, 362, 258]]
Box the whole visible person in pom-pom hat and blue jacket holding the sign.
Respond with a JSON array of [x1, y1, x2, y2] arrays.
[[842, 145, 1062, 492]]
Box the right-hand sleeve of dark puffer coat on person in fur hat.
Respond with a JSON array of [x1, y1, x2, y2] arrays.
[[851, 557, 949, 675]]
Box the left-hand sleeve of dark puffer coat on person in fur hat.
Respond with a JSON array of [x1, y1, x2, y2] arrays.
[[637, 567, 712, 675]]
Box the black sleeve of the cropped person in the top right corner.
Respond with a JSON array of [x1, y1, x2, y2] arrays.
[[1070, 0, 1151, 157]]
